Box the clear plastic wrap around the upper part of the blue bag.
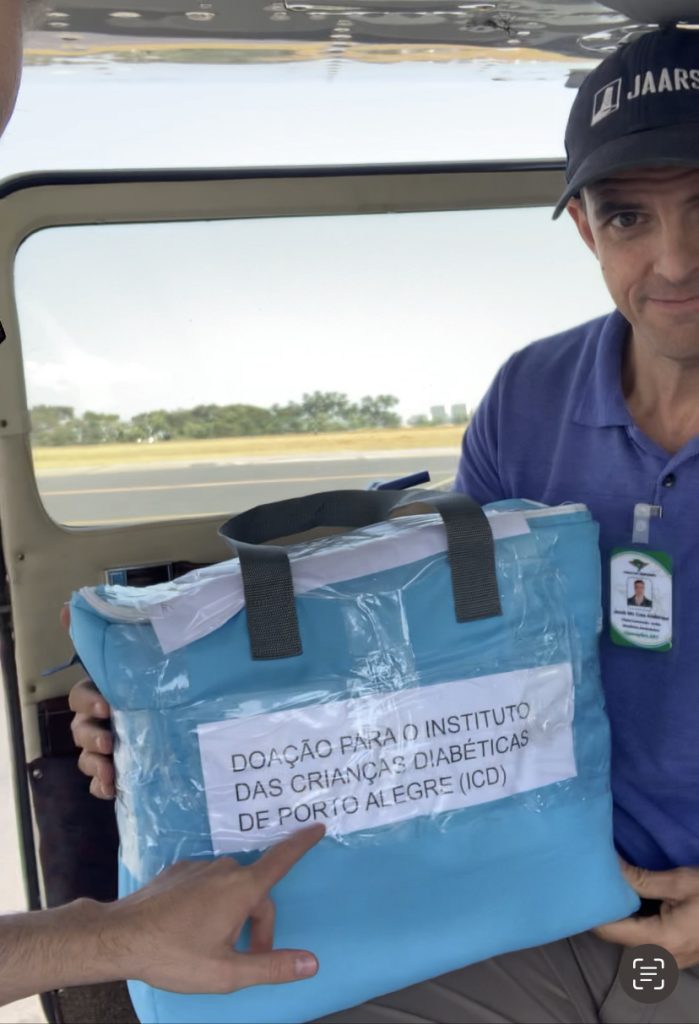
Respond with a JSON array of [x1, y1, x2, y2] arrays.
[[68, 506, 609, 883]]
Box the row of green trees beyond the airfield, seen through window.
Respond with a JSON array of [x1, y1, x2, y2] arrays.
[[30, 391, 470, 446]]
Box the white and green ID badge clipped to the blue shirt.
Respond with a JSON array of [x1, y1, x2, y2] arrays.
[[609, 548, 672, 651]]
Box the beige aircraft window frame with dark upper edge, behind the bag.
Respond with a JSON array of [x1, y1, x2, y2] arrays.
[[0, 161, 565, 937]]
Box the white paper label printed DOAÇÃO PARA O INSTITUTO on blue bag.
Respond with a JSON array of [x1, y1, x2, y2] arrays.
[[198, 663, 576, 854]]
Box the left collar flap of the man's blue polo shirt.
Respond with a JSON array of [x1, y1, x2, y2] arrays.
[[573, 309, 632, 427]]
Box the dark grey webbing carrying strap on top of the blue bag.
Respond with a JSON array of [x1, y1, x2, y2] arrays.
[[219, 490, 501, 659]]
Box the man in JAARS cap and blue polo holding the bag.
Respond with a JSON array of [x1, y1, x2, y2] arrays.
[[72, 16, 699, 1024]]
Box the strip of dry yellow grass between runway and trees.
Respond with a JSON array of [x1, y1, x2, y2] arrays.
[[34, 426, 464, 472]]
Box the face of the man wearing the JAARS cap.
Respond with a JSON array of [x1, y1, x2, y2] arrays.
[[569, 168, 699, 364]]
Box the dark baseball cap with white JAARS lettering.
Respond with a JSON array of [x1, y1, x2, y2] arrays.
[[554, 27, 699, 218]]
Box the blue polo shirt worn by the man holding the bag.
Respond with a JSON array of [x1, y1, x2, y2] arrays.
[[455, 312, 699, 870]]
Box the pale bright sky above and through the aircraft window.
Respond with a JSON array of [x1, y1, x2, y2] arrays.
[[0, 54, 610, 418]]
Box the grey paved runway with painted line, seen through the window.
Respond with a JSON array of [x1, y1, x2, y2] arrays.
[[38, 449, 457, 525]]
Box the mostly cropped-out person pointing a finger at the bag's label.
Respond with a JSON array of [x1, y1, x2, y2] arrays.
[[0, 0, 323, 1005]]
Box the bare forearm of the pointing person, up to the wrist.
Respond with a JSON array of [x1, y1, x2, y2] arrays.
[[0, 899, 126, 1006]]
